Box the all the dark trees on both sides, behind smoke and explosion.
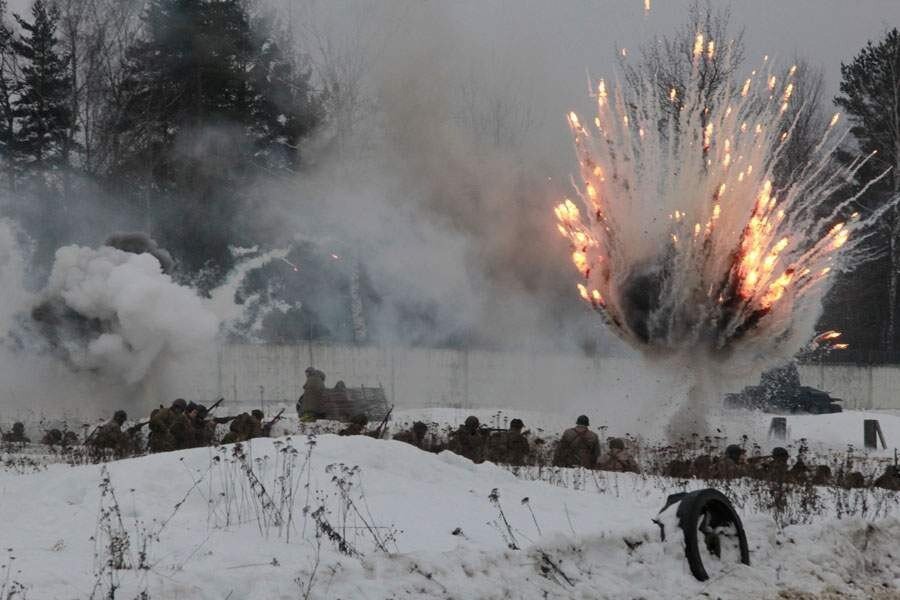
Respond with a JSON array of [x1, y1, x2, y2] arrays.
[[0, 0, 900, 362]]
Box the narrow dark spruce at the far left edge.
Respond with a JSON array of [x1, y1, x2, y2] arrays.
[[12, 0, 73, 181]]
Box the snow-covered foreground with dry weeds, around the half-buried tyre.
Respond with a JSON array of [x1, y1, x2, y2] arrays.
[[0, 413, 900, 600]]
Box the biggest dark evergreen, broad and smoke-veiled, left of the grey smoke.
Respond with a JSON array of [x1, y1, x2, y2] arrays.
[[118, 0, 320, 280]]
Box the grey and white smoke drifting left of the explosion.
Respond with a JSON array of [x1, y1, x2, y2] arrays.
[[7, 0, 900, 422]]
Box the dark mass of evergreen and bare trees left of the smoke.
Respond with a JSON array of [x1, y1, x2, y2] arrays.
[[0, 0, 325, 282]]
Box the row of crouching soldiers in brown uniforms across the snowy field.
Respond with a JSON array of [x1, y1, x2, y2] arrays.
[[0, 367, 900, 490]]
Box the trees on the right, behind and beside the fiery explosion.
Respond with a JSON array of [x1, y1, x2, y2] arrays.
[[621, 0, 900, 363]]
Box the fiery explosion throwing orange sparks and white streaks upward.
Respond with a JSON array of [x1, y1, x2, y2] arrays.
[[556, 34, 888, 366]]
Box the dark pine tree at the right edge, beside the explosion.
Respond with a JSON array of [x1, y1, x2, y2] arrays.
[[834, 29, 900, 351]]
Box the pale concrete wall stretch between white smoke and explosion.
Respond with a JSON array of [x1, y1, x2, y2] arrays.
[[171, 343, 639, 408]]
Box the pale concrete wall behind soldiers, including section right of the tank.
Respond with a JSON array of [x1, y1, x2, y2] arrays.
[[162, 343, 900, 409]]
